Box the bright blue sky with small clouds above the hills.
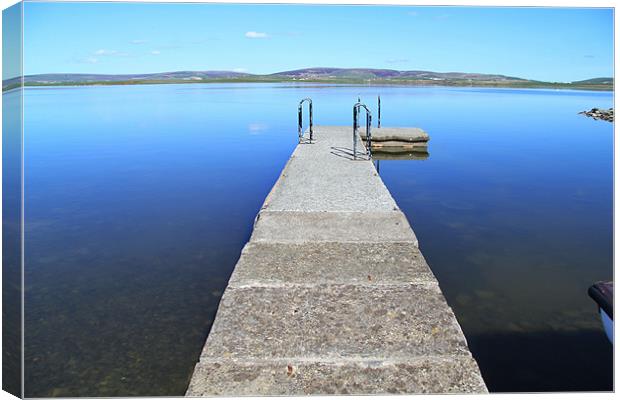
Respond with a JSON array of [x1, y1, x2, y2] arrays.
[[24, 2, 613, 81]]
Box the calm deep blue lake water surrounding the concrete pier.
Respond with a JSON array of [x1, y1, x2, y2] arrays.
[[13, 84, 613, 397]]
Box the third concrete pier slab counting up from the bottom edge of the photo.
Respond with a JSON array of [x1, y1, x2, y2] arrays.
[[228, 242, 436, 287]]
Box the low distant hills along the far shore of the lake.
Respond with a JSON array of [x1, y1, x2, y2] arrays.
[[2, 68, 613, 91]]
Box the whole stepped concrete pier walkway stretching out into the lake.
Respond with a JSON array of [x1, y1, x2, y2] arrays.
[[186, 126, 487, 396]]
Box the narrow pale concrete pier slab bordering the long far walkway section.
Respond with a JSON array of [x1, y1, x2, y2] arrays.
[[250, 211, 418, 246]]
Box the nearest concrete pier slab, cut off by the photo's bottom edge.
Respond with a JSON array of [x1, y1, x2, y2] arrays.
[[187, 357, 486, 396]]
